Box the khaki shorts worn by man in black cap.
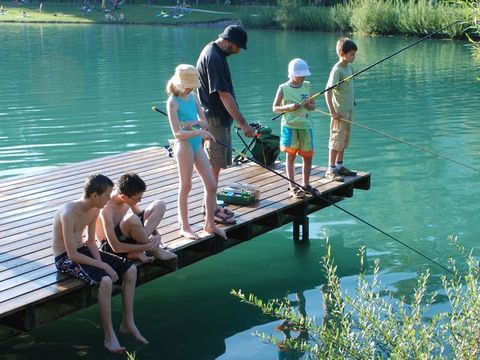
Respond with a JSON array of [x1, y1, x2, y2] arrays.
[[205, 117, 232, 169]]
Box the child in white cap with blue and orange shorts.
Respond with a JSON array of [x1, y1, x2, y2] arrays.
[[272, 58, 320, 198]]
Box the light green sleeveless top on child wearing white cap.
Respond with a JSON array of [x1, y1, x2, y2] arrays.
[[280, 81, 311, 129]]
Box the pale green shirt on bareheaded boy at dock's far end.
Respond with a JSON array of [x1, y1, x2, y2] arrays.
[[327, 63, 355, 112]]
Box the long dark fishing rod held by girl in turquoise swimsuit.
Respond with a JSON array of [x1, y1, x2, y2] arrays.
[[152, 106, 455, 274]]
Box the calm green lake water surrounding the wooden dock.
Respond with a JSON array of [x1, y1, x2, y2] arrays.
[[0, 25, 480, 359]]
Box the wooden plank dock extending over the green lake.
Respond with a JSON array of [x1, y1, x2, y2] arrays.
[[0, 147, 370, 330]]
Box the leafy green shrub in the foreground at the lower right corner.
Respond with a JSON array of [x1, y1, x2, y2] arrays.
[[232, 233, 480, 359]]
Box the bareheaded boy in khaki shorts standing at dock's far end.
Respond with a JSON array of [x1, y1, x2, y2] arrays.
[[325, 37, 358, 181]]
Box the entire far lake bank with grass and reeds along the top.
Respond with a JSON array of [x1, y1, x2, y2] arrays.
[[0, 0, 468, 39]]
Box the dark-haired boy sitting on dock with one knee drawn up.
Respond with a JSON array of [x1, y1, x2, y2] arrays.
[[97, 173, 177, 267]]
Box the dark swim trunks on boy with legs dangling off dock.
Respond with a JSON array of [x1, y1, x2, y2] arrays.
[[55, 245, 133, 286]]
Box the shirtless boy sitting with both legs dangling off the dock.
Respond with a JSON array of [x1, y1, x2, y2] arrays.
[[52, 174, 148, 353]]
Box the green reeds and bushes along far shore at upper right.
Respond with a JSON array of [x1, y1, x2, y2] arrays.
[[246, 0, 468, 38]]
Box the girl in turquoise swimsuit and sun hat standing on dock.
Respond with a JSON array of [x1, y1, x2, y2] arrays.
[[166, 64, 230, 240]]
